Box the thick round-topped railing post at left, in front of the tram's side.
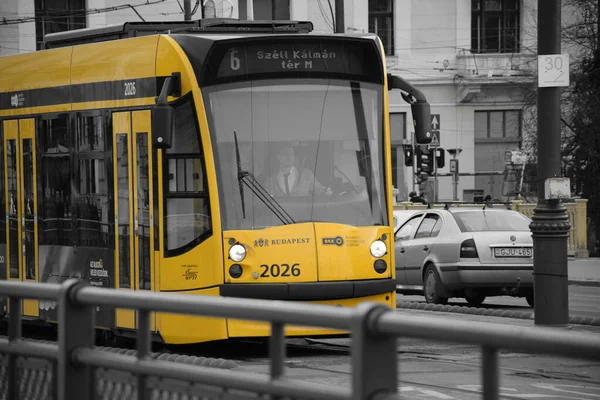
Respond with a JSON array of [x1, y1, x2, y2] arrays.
[[58, 279, 96, 400]]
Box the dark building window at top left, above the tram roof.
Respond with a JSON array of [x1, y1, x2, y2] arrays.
[[35, 0, 86, 50]]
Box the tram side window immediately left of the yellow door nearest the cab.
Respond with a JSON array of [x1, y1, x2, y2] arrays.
[[74, 115, 110, 248]]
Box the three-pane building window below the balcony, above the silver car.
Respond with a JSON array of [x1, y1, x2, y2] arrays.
[[475, 110, 521, 141]]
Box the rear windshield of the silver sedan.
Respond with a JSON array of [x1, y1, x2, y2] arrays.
[[452, 210, 531, 232]]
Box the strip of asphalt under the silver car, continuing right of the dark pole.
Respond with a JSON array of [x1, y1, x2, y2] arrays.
[[397, 285, 600, 318]]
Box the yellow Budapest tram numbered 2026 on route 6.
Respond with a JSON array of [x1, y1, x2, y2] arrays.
[[0, 20, 429, 343]]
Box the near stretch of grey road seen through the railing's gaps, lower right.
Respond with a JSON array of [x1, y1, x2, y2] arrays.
[[232, 318, 600, 400]]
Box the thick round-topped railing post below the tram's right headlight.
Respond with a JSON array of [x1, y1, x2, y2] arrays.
[[351, 302, 398, 400]]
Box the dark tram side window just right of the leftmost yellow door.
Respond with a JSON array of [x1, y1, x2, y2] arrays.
[[40, 115, 73, 246]]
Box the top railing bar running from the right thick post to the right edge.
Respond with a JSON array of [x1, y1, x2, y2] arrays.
[[373, 312, 600, 360]]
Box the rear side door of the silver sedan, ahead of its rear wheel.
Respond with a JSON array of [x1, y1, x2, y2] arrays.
[[404, 213, 441, 285]]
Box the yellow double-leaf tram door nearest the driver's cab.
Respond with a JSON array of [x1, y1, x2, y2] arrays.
[[112, 110, 156, 330]]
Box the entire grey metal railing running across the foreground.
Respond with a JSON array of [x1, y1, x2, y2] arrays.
[[0, 279, 600, 400]]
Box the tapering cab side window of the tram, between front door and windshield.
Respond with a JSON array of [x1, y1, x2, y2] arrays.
[[163, 101, 212, 256]]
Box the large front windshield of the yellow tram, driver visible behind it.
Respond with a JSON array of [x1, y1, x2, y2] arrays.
[[204, 79, 387, 229]]
